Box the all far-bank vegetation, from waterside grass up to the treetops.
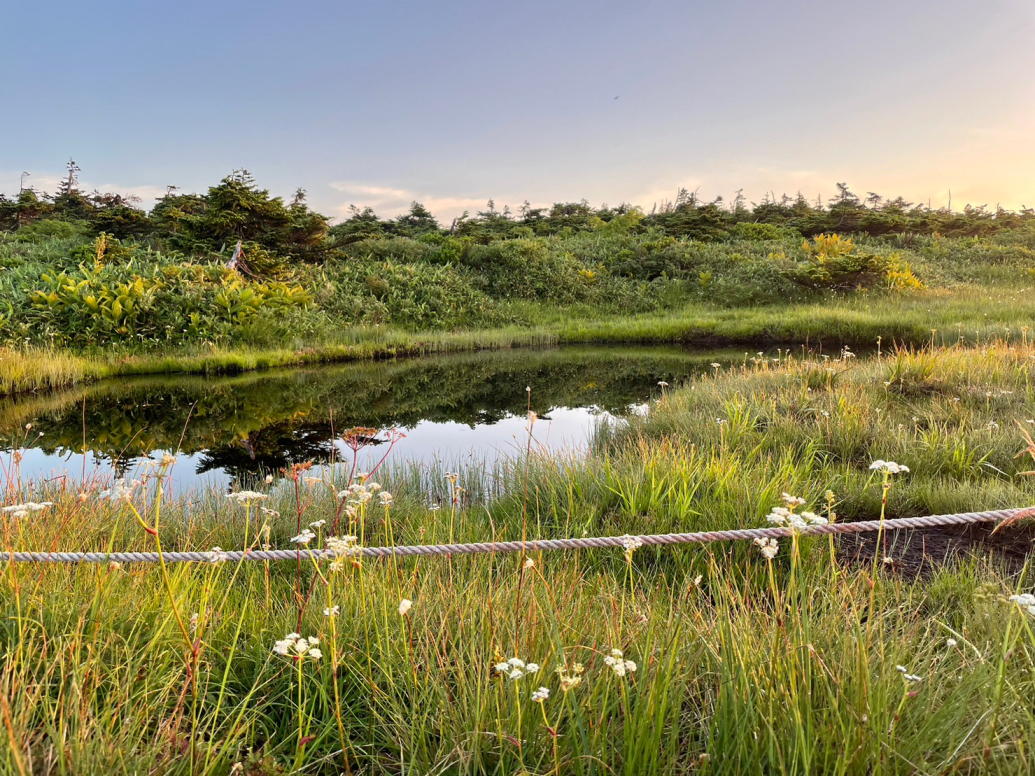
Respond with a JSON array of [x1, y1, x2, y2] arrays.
[[0, 171, 1035, 392]]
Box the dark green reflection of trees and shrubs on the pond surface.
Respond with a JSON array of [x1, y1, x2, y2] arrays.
[[0, 347, 742, 481]]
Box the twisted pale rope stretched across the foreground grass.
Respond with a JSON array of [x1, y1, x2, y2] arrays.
[[0, 507, 1035, 563]]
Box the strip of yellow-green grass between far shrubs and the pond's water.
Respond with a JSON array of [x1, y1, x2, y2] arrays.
[[0, 279, 1035, 395]]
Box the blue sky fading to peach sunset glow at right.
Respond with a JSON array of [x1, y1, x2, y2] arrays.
[[0, 0, 1035, 221]]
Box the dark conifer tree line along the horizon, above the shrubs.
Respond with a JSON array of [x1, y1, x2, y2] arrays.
[[0, 161, 1035, 263]]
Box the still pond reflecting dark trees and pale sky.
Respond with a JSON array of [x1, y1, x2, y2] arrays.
[[0, 347, 743, 491]]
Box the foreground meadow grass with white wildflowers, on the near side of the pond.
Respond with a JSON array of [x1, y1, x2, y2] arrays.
[[0, 347, 1035, 775]]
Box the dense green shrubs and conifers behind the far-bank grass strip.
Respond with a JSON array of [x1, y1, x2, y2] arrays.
[[0, 172, 1035, 349]]
